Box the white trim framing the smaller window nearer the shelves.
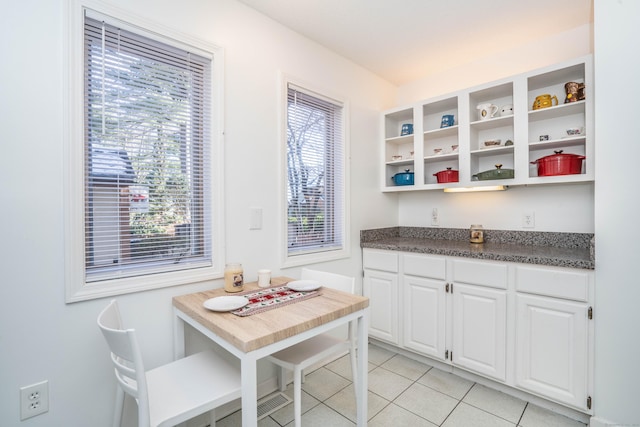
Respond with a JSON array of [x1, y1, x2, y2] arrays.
[[278, 72, 351, 268]]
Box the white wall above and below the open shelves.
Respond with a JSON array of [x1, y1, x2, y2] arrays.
[[398, 25, 594, 233]]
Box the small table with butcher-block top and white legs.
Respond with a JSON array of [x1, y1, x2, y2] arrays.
[[173, 277, 369, 427]]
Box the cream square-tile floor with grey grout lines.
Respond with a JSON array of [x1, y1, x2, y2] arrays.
[[216, 345, 585, 427]]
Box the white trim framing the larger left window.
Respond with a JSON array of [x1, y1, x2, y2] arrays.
[[63, 0, 225, 303]]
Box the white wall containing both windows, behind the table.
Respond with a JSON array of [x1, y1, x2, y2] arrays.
[[0, 0, 397, 427]]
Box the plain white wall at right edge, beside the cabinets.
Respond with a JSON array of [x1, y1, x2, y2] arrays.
[[592, 0, 640, 427]]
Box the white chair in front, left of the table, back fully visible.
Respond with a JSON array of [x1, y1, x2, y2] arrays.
[[98, 300, 241, 427]]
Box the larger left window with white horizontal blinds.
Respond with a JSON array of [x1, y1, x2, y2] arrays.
[[67, 4, 221, 300]]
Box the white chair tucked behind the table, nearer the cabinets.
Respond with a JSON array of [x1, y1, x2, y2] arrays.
[[268, 268, 356, 427]]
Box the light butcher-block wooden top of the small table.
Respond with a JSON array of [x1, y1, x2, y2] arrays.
[[173, 277, 369, 352]]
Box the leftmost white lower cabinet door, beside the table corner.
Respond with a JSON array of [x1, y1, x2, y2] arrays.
[[363, 270, 399, 344]]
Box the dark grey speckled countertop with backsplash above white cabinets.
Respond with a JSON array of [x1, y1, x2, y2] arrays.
[[360, 227, 595, 270]]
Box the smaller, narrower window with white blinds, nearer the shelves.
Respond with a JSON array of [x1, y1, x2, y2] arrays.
[[285, 82, 348, 265]]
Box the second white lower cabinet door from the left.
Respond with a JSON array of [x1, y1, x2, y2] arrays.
[[402, 276, 446, 360]]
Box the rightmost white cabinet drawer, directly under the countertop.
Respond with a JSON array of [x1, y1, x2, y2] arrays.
[[516, 266, 590, 302]]
